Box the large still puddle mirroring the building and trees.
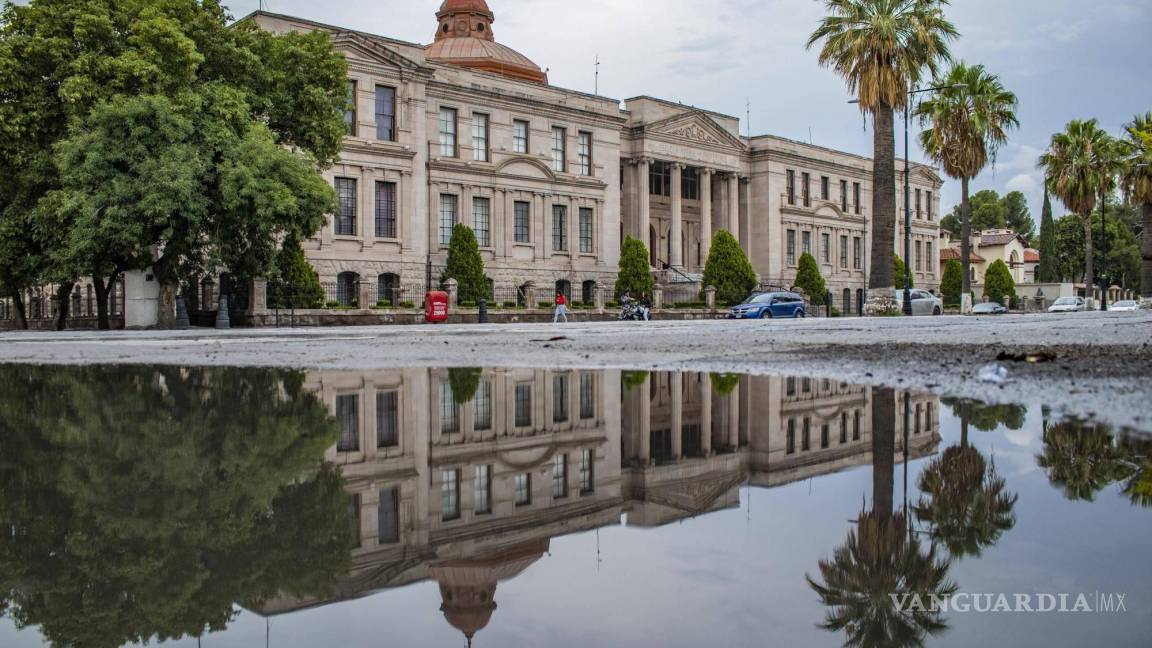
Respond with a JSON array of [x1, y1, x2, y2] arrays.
[[0, 366, 1152, 648]]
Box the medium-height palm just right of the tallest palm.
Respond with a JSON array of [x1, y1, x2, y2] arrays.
[[916, 62, 1020, 295]]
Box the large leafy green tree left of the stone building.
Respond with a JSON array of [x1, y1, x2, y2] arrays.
[[0, 0, 347, 327]]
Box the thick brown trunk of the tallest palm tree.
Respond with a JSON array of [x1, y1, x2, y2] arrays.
[[869, 105, 896, 291]]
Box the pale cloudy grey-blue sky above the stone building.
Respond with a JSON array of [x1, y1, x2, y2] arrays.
[[11, 0, 1152, 221]]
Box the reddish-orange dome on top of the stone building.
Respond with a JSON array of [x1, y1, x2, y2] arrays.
[[424, 0, 548, 83]]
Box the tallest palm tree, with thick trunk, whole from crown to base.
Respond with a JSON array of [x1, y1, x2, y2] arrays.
[[808, 0, 958, 312]]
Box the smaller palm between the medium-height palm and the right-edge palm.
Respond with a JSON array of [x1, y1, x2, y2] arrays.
[[1040, 119, 1119, 295]]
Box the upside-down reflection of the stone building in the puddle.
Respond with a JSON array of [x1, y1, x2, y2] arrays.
[[252, 369, 940, 638]]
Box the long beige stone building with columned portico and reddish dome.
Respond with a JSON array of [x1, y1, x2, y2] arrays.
[[249, 0, 941, 311]]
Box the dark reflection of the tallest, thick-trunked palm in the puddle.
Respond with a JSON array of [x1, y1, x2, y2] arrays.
[[806, 389, 956, 648]]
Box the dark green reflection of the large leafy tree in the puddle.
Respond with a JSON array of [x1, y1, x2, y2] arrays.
[[0, 367, 351, 647]]
